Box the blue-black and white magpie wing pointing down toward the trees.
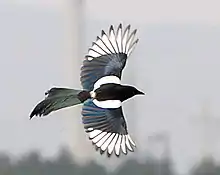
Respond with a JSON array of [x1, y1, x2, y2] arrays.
[[82, 100, 135, 156]]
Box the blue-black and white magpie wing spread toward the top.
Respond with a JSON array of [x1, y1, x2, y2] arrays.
[[80, 24, 138, 91]]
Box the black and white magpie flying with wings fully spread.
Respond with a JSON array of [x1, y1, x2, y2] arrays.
[[30, 24, 144, 156]]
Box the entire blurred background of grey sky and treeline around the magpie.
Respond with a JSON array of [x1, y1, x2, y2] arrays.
[[0, 0, 220, 175]]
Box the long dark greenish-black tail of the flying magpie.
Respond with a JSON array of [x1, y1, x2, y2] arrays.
[[30, 88, 90, 119]]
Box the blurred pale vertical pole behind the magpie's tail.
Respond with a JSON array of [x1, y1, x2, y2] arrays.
[[64, 0, 91, 162]]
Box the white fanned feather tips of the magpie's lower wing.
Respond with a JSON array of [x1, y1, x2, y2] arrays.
[[87, 128, 136, 156]]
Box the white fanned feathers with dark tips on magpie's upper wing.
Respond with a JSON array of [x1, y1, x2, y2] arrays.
[[86, 24, 138, 61]]
